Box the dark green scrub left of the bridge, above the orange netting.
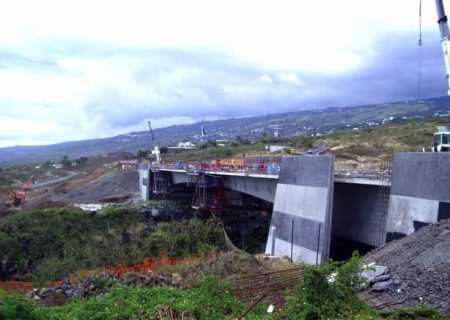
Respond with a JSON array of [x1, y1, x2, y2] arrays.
[[0, 209, 225, 280]]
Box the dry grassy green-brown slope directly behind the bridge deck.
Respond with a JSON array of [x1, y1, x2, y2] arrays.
[[160, 117, 450, 162]]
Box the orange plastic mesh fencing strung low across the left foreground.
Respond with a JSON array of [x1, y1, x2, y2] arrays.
[[0, 252, 221, 294]]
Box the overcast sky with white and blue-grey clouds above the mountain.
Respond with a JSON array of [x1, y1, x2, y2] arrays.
[[0, 0, 450, 147]]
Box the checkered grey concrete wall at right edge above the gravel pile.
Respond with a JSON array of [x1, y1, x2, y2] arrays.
[[387, 152, 450, 241]]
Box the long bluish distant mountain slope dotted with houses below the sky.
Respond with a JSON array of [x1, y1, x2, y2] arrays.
[[0, 97, 450, 165]]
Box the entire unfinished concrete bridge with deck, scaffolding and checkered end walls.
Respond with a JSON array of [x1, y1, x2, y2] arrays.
[[139, 153, 450, 264]]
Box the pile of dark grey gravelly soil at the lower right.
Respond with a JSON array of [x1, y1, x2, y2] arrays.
[[364, 219, 450, 314]]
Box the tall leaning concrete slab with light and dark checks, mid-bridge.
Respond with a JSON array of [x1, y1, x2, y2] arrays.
[[266, 156, 334, 264]]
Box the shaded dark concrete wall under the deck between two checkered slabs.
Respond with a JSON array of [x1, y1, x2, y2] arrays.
[[331, 183, 387, 247]]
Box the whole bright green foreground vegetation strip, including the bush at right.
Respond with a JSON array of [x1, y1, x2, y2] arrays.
[[0, 255, 446, 320]]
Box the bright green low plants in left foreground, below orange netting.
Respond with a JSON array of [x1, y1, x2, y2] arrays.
[[0, 277, 271, 320]]
